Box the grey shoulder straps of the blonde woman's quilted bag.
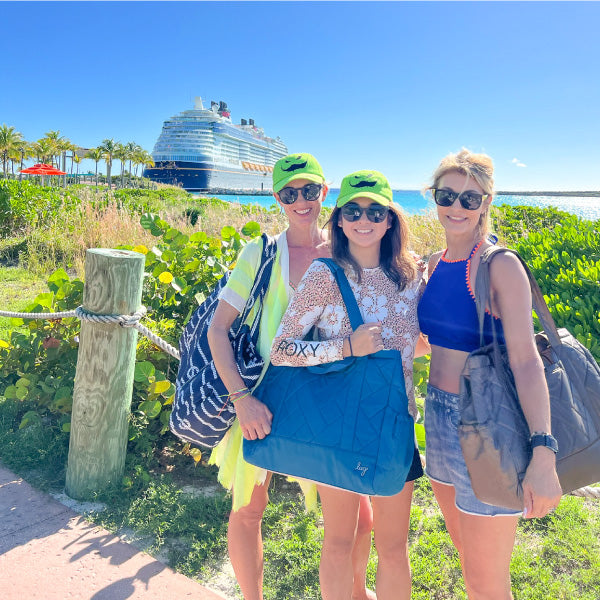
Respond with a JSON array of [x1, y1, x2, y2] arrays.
[[475, 246, 560, 348]]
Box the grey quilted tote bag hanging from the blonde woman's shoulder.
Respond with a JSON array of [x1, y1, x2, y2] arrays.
[[458, 247, 600, 510]]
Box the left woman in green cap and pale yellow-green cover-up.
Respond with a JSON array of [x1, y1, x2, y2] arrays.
[[208, 153, 371, 600]]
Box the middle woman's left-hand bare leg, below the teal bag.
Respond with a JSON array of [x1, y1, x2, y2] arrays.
[[317, 485, 360, 600]]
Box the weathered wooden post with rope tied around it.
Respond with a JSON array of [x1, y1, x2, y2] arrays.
[[66, 248, 144, 500]]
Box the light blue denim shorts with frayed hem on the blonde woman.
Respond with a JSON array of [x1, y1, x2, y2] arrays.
[[425, 385, 521, 517]]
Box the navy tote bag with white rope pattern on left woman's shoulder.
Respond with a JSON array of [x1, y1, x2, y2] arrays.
[[169, 234, 277, 448]]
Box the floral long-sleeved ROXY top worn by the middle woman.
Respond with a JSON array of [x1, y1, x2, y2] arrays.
[[271, 262, 425, 418]]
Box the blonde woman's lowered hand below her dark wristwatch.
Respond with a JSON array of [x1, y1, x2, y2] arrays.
[[523, 446, 562, 519]]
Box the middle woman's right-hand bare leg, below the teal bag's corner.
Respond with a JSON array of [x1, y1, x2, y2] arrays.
[[372, 481, 414, 600]]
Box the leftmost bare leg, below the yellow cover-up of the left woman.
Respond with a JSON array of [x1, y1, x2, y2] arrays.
[[227, 473, 271, 600]]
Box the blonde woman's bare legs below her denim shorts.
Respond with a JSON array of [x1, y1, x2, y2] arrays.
[[431, 482, 519, 600]]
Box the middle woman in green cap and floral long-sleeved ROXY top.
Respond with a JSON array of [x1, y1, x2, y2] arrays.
[[271, 171, 426, 600]]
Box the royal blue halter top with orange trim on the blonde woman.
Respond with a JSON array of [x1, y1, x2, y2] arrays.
[[418, 242, 504, 352]]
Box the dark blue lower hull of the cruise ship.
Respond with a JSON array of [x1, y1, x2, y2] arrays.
[[144, 161, 272, 194]]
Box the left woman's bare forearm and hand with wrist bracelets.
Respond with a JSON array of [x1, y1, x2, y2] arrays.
[[207, 300, 273, 440]]
